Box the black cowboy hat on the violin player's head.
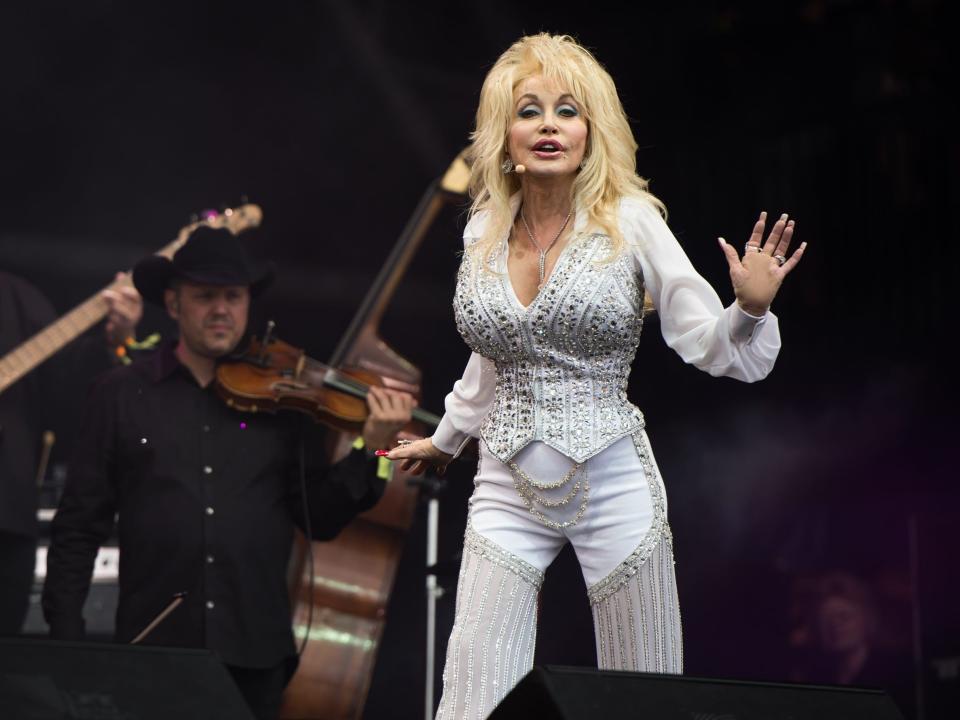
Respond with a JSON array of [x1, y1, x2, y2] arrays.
[[133, 225, 276, 306]]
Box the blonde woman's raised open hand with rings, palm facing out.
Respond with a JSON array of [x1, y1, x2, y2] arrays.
[[718, 212, 807, 315]]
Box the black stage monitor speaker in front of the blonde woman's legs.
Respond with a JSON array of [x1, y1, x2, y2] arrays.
[[489, 665, 903, 720]]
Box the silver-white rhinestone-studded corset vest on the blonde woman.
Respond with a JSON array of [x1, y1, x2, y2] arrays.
[[454, 234, 643, 462]]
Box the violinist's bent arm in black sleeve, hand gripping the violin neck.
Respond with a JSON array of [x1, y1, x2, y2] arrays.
[[294, 388, 413, 540]]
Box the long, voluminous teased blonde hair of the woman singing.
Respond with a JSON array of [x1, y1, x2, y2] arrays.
[[469, 33, 666, 264]]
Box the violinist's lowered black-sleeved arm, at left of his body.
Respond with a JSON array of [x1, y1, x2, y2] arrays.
[[43, 376, 116, 640]]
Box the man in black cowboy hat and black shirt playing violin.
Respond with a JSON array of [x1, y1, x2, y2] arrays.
[[43, 227, 413, 719]]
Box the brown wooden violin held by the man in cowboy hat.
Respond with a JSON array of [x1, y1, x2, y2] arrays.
[[214, 321, 440, 434]]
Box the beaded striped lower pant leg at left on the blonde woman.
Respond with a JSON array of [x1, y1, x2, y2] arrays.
[[437, 525, 543, 720]]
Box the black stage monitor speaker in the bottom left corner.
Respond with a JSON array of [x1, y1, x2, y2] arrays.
[[0, 638, 253, 720]]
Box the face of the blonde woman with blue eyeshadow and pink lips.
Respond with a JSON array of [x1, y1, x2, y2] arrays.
[[507, 75, 589, 177]]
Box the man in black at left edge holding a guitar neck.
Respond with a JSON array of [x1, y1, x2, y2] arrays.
[[0, 272, 143, 636]]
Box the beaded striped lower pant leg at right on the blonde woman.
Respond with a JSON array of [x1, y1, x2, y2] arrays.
[[590, 531, 683, 674]]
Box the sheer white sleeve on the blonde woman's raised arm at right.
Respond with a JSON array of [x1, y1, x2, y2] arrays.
[[621, 194, 780, 382]]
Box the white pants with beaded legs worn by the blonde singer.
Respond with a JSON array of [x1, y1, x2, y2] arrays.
[[437, 431, 683, 720]]
